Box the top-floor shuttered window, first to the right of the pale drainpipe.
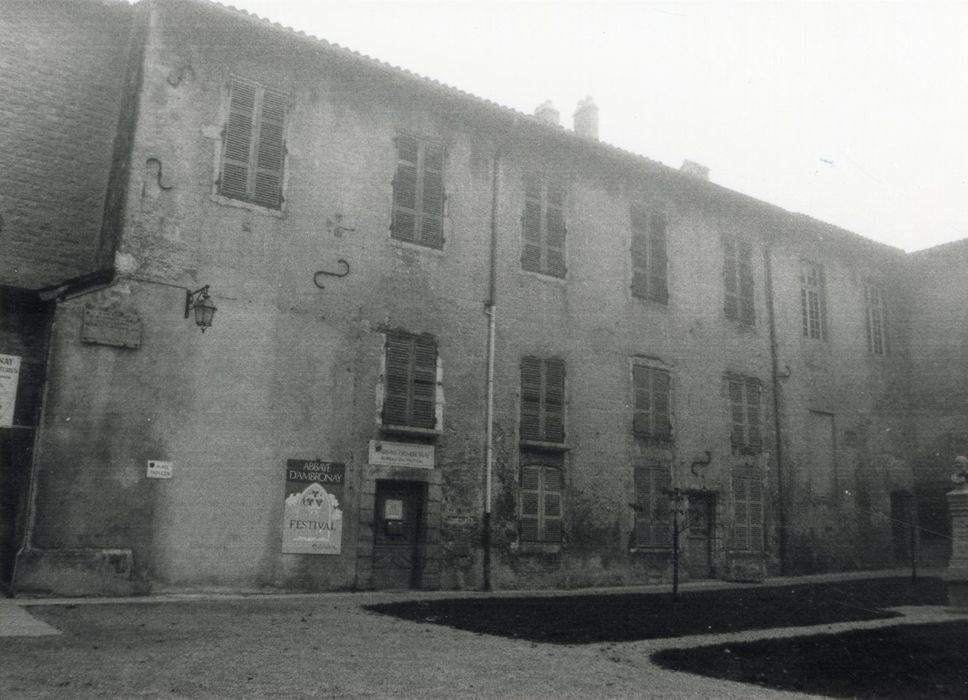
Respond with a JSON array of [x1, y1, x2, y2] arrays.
[[521, 175, 565, 277]]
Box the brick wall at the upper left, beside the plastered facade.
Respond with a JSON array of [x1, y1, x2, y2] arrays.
[[0, 0, 131, 288]]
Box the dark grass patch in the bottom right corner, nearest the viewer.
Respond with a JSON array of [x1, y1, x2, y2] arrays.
[[652, 621, 968, 700]]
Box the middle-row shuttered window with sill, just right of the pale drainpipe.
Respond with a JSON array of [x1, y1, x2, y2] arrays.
[[521, 357, 565, 443]]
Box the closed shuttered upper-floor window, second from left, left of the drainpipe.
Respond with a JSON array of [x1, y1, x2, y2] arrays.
[[390, 136, 444, 248]]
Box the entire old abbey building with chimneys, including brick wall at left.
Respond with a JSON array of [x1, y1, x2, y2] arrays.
[[0, 0, 952, 594]]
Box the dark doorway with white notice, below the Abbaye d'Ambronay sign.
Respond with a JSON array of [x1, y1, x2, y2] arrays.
[[373, 481, 427, 589]]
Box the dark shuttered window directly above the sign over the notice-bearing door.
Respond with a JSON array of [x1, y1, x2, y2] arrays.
[[383, 333, 437, 429]]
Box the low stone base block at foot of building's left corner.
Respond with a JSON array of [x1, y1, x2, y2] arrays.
[[13, 549, 137, 596]]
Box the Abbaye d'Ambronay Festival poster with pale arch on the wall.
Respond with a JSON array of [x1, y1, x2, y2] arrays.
[[282, 459, 346, 554]]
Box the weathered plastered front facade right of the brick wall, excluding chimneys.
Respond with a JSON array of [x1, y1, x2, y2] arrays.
[[0, 0, 965, 593]]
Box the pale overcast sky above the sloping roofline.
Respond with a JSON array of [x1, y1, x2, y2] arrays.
[[199, 0, 968, 250]]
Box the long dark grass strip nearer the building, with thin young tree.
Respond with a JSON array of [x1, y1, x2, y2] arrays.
[[367, 578, 946, 644]]
